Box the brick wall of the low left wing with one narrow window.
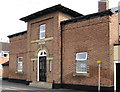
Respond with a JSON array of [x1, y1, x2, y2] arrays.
[[9, 34, 28, 80]]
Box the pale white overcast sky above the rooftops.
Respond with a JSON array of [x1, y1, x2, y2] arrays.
[[0, 0, 120, 39]]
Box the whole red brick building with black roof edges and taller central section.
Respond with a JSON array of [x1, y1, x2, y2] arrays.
[[3, 0, 119, 90]]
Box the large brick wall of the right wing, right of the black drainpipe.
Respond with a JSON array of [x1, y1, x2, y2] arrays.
[[63, 15, 118, 87]]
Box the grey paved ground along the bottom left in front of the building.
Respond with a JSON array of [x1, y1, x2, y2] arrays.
[[0, 78, 85, 92]]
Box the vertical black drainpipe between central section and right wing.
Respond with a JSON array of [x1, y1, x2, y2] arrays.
[[60, 22, 63, 88]]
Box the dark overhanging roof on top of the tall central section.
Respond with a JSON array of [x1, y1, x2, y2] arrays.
[[20, 4, 83, 22]]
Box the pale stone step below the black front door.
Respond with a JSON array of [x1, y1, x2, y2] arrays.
[[29, 82, 52, 89]]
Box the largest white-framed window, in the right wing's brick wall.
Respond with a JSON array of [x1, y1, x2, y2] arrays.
[[76, 52, 87, 73]]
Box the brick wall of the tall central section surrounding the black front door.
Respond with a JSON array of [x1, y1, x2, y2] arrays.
[[27, 12, 71, 83]]
